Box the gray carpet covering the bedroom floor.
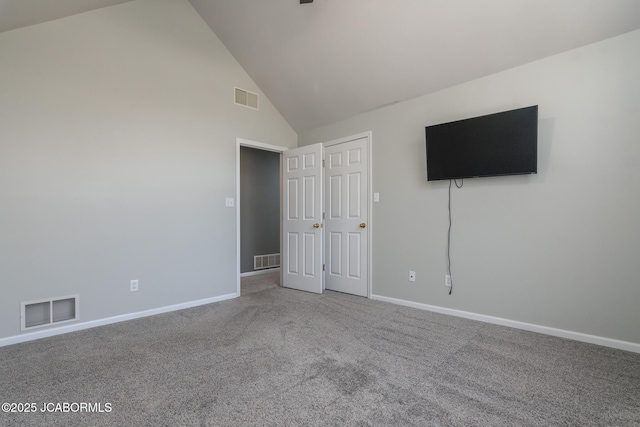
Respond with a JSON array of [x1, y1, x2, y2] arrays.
[[0, 272, 640, 426]]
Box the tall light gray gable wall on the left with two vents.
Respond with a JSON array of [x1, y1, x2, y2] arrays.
[[0, 0, 297, 338]]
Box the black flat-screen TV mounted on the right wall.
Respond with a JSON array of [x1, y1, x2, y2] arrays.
[[425, 105, 538, 181]]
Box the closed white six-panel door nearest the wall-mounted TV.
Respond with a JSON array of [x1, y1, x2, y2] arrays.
[[325, 137, 369, 297]]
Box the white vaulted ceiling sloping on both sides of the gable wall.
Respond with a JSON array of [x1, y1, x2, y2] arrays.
[[0, 0, 640, 131]]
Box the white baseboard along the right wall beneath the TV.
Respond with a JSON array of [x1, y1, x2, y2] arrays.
[[371, 295, 640, 353]]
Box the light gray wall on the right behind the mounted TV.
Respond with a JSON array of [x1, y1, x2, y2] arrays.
[[299, 31, 640, 343]]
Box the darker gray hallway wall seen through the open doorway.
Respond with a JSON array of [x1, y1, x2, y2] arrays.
[[240, 147, 280, 273]]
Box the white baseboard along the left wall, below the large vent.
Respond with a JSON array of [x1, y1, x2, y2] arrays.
[[0, 293, 237, 347]]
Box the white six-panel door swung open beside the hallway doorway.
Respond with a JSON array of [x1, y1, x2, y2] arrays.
[[281, 144, 323, 294]]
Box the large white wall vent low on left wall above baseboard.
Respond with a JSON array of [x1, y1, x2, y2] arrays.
[[20, 295, 79, 331]]
